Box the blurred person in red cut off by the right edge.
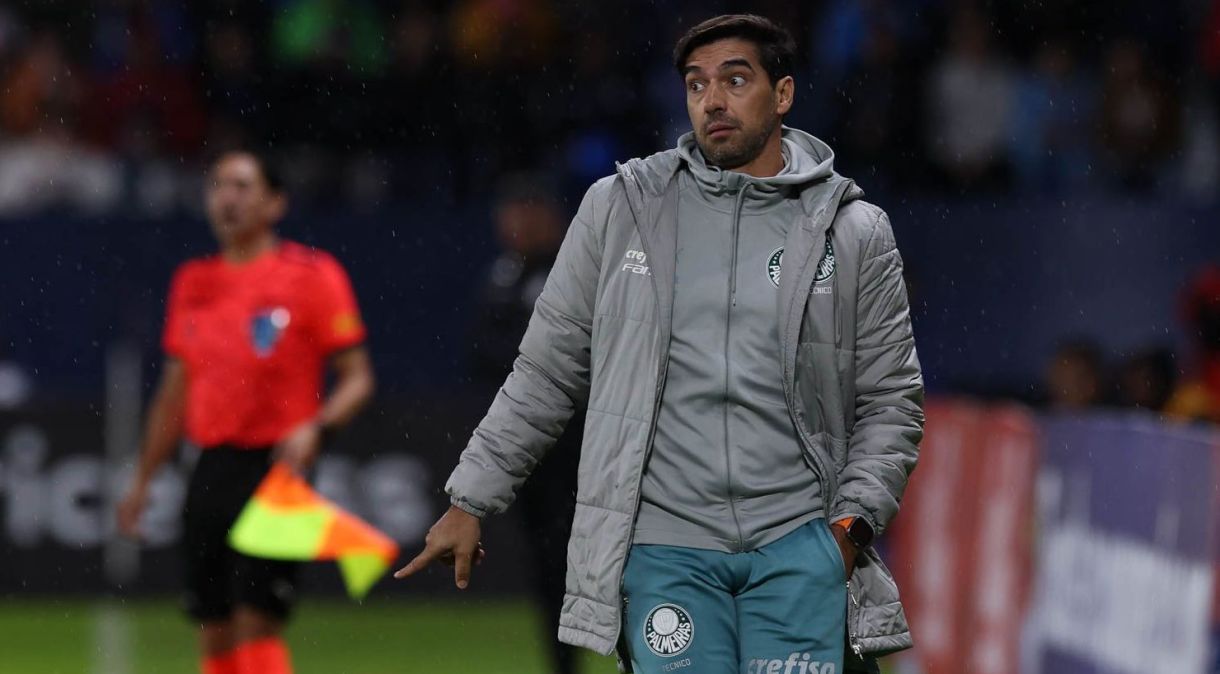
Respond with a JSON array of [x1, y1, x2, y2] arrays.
[[1165, 265, 1220, 424]]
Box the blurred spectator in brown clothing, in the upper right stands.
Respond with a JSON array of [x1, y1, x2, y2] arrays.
[[1099, 39, 1180, 192]]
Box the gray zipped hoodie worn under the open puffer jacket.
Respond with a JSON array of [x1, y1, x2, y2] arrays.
[[634, 133, 832, 552]]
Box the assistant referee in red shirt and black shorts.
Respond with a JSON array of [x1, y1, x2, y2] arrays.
[[118, 151, 373, 674]]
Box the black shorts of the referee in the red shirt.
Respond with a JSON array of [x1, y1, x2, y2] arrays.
[[182, 446, 300, 623]]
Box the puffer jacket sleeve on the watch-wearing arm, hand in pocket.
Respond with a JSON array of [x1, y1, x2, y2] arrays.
[[831, 212, 924, 534]]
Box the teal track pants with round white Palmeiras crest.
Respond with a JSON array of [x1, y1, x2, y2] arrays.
[[622, 519, 847, 674]]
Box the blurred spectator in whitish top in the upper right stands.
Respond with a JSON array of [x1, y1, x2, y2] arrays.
[[927, 5, 1013, 188]]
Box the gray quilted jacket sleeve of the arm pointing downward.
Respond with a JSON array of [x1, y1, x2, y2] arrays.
[[445, 183, 601, 516]]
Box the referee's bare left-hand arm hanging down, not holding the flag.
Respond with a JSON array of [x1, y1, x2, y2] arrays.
[[118, 358, 187, 537]]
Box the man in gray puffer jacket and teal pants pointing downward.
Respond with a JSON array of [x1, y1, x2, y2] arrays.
[[398, 16, 924, 674]]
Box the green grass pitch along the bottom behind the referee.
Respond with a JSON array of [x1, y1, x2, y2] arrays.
[[0, 598, 616, 674]]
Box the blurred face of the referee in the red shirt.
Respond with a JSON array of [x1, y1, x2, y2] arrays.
[[206, 154, 287, 244]]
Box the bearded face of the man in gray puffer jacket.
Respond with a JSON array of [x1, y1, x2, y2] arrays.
[[686, 38, 793, 169]]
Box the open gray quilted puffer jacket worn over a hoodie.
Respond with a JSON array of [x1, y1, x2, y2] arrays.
[[447, 128, 924, 669]]
